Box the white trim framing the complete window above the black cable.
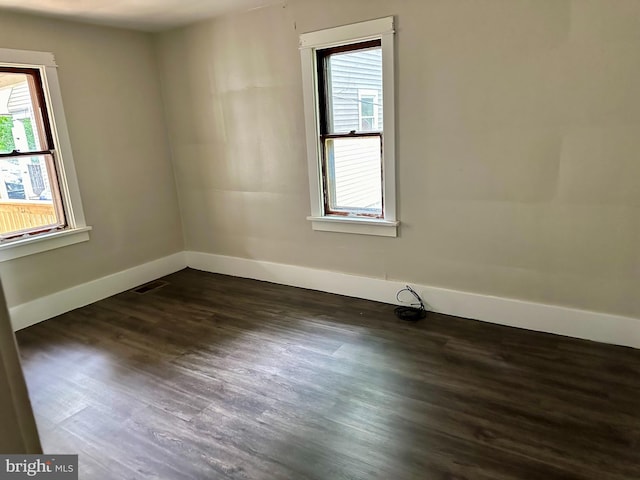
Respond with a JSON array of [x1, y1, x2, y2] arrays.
[[300, 17, 400, 237]]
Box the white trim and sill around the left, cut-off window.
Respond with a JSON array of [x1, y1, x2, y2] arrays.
[[0, 48, 91, 262]]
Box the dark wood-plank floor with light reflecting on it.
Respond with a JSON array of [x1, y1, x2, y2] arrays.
[[17, 270, 640, 480]]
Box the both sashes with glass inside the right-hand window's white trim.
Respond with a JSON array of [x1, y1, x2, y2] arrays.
[[319, 40, 383, 218]]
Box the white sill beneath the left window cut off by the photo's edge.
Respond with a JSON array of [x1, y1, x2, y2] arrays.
[[0, 227, 91, 262]]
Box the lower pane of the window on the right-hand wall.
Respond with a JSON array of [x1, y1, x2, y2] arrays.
[[326, 136, 382, 216]]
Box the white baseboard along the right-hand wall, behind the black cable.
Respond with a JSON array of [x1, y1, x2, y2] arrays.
[[185, 252, 640, 348]]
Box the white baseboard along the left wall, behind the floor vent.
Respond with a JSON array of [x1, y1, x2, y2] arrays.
[[9, 252, 186, 331]]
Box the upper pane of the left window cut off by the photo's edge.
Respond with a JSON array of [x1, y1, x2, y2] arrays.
[[0, 71, 48, 153]]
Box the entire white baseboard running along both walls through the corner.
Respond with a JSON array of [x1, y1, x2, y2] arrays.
[[9, 248, 640, 348]]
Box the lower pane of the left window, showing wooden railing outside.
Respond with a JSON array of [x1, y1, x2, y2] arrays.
[[0, 155, 63, 236]]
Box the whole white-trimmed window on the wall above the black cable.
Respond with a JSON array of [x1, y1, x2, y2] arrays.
[[300, 17, 398, 236]]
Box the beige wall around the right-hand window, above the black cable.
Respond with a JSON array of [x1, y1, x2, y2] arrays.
[[158, 0, 640, 316]]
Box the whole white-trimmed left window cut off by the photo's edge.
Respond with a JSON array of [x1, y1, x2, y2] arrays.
[[0, 49, 90, 261]]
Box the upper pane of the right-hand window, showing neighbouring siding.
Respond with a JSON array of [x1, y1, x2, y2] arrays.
[[327, 47, 382, 133]]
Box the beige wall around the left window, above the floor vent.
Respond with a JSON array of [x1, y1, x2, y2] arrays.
[[0, 11, 183, 305]]
